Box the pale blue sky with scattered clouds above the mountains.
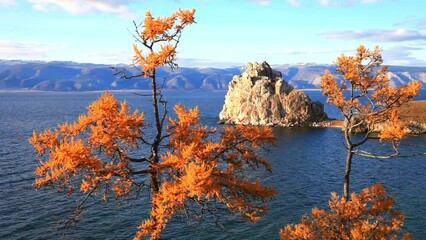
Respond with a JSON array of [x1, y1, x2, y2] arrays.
[[0, 0, 426, 68]]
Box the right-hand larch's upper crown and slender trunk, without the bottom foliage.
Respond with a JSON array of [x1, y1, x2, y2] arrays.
[[321, 45, 421, 199]]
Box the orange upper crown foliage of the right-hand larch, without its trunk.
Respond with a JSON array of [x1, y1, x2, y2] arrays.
[[321, 45, 420, 141]]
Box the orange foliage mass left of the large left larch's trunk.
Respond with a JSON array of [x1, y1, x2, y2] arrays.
[[29, 92, 144, 197]]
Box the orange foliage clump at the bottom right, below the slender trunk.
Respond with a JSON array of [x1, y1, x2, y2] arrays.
[[280, 183, 411, 239]]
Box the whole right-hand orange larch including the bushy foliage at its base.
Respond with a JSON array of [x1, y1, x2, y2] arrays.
[[280, 45, 420, 240]]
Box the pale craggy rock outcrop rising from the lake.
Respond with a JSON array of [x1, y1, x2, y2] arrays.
[[219, 62, 327, 126]]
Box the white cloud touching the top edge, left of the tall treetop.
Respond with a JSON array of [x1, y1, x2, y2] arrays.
[[27, 0, 135, 18]]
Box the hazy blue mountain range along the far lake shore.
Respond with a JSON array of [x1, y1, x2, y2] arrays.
[[0, 60, 426, 91]]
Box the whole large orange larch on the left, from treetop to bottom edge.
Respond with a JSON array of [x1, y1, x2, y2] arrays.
[[29, 9, 275, 239]]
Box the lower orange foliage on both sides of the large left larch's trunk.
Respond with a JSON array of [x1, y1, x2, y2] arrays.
[[29, 92, 275, 239]]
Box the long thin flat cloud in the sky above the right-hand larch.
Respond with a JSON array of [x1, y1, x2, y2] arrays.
[[321, 29, 426, 42]]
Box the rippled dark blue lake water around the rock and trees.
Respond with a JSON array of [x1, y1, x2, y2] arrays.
[[0, 91, 426, 239]]
